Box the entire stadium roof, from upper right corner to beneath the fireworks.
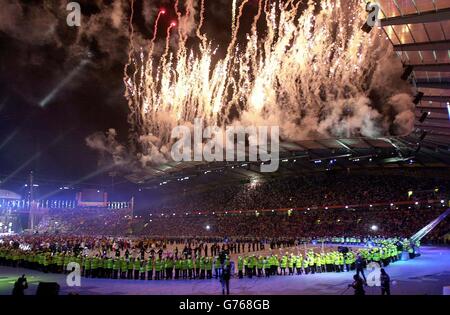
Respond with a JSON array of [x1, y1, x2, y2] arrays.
[[127, 0, 450, 185]]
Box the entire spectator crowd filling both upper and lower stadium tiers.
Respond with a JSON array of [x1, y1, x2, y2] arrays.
[[29, 169, 450, 241]]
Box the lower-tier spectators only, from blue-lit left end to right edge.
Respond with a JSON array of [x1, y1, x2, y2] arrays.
[[32, 204, 450, 242]]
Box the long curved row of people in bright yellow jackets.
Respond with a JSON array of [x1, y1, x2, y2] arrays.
[[0, 239, 414, 280]]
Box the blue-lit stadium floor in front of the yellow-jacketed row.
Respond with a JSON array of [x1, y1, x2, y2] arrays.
[[0, 247, 450, 295]]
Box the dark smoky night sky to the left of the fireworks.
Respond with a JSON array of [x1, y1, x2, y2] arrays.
[[0, 0, 258, 194]]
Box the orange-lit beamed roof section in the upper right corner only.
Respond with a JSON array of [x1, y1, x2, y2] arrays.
[[377, 0, 450, 152]]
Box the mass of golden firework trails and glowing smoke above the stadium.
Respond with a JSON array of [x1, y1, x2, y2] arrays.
[[120, 0, 414, 168]]
